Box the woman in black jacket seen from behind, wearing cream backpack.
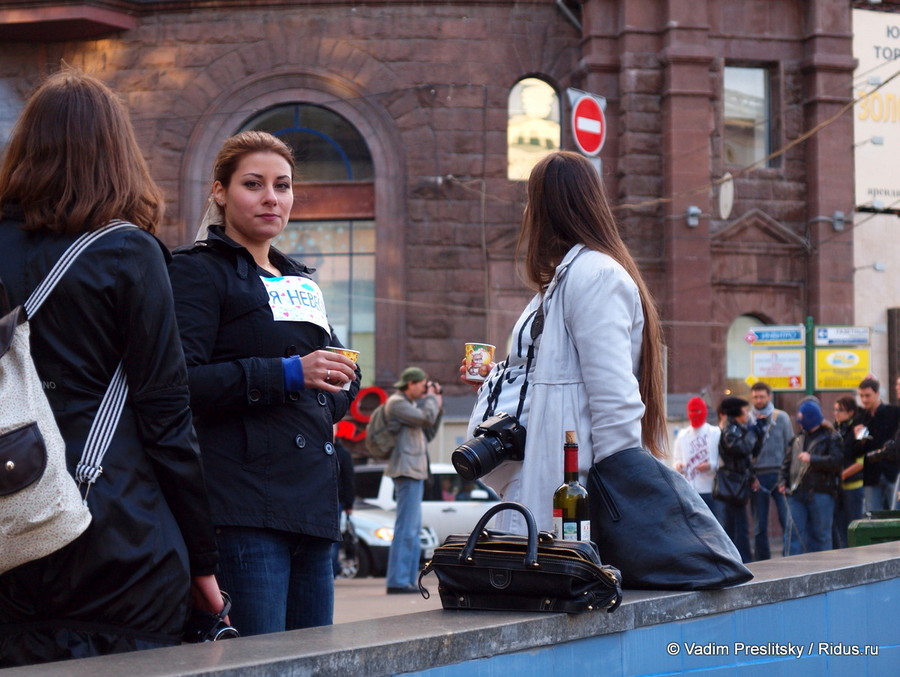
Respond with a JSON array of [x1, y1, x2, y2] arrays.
[[0, 69, 223, 667]]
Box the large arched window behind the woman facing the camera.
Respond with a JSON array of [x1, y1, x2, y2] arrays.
[[241, 103, 376, 386]]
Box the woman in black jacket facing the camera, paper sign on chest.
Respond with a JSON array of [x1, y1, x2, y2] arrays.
[[169, 132, 359, 635]]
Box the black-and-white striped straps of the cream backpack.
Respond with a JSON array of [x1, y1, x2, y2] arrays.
[[23, 219, 137, 504]]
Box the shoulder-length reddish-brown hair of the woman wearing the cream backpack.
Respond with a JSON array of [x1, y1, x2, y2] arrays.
[[0, 66, 164, 233]]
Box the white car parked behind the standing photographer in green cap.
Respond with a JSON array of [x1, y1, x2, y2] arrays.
[[354, 463, 500, 543]]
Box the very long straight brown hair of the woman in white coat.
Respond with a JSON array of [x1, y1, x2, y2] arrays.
[[518, 151, 666, 457]]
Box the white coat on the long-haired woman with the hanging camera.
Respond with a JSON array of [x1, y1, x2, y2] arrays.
[[469, 245, 644, 533]]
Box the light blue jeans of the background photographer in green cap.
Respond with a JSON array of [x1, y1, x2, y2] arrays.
[[385, 477, 425, 588]]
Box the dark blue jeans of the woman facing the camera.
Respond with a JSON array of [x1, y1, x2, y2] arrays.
[[216, 527, 334, 636]]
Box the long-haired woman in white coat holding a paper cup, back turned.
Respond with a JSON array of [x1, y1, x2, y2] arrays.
[[470, 151, 665, 532]]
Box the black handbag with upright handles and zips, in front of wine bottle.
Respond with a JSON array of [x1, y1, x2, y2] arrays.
[[419, 502, 622, 613]]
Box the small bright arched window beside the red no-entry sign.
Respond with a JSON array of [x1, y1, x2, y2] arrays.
[[506, 78, 560, 181]]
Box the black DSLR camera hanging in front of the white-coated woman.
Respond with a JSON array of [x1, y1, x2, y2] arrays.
[[450, 412, 525, 482]]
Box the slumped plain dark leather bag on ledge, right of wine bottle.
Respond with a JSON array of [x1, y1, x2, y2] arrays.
[[587, 449, 753, 590]]
